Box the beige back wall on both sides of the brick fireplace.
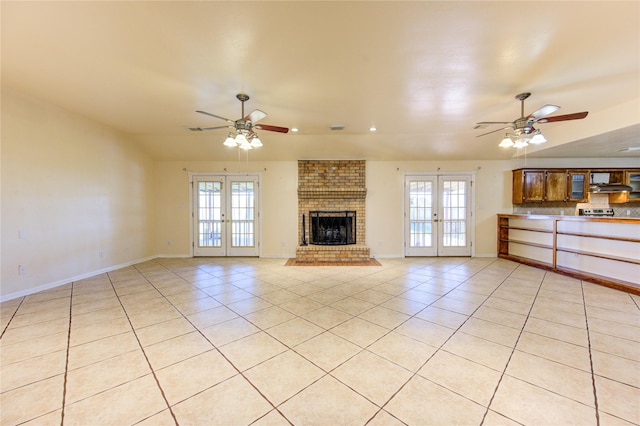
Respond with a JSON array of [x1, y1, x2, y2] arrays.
[[156, 161, 511, 258]]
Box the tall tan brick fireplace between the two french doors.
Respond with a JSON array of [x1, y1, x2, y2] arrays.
[[296, 160, 371, 263]]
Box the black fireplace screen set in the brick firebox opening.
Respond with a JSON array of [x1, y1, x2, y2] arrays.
[[309, 210, 356, 245]]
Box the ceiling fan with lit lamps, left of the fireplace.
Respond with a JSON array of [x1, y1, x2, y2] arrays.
[[189, 93, 289, 150]]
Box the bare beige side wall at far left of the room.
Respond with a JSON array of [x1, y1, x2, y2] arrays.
[[0, 88, 155, 299]]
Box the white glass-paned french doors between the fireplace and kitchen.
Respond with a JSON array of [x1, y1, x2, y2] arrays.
[[404, 174, 473, 256]]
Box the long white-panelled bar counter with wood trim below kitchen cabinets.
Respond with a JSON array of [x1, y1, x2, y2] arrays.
[[498, 214, 640, 295]]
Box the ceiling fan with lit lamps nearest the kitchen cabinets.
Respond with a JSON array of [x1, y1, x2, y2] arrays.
[[474, 92, 589, 148]]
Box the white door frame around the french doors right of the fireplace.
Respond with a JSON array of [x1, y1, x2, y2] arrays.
[[402, 171, 476, 257]]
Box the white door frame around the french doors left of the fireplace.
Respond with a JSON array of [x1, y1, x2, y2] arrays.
[[189, 171, 262, 257]]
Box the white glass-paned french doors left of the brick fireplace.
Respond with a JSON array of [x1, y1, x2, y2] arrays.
[[192, 175, 259, 256]]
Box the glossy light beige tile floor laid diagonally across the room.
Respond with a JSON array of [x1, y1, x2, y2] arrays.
[[0, 258, 640, 426]]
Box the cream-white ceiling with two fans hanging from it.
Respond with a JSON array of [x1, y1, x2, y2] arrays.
[[0, 1, 640, 160]]
